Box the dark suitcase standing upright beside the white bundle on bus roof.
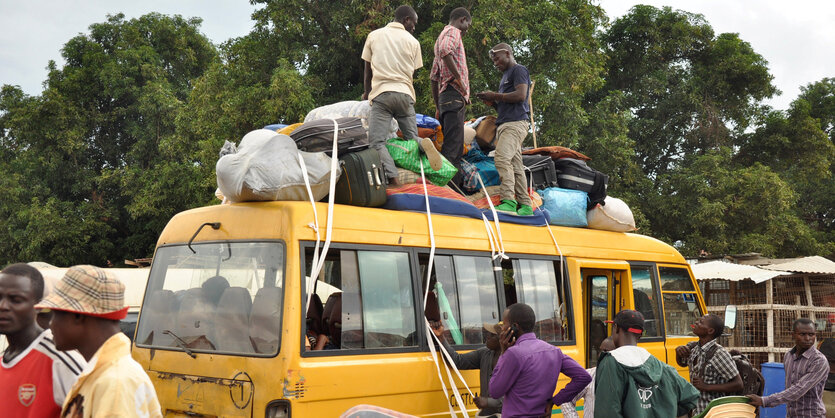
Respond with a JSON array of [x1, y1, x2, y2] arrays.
[[334, 149, 386, 207]]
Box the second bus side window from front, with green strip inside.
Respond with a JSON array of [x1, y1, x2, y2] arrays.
[[421, 254, 501, 345]]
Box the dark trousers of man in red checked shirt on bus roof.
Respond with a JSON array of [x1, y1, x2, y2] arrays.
[[438, 86, 467, 187]]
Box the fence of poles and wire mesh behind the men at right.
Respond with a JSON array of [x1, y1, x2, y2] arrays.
[[699, 274, 835, 367]]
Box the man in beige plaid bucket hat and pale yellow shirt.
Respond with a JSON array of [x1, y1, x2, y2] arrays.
[[36, 265, 162, 418]]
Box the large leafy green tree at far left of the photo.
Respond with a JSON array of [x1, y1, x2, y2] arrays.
[[0, 14, 217, 265]]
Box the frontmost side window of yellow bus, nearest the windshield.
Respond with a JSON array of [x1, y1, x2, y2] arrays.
[[305, 249, 416, 350]]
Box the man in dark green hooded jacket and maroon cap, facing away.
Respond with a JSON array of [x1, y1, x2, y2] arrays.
[[594, 309, 699, 418]]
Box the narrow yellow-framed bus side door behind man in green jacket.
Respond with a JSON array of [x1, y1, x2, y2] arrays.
[[580, 261, 628, 368]]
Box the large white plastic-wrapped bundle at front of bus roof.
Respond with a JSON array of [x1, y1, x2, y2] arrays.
[[220, 129, 341, 202]]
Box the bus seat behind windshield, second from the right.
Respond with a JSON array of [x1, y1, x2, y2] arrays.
[[215, 287, 252, 353]]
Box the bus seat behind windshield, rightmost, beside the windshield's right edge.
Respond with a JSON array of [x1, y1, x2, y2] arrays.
[[249, 287, 281, 353]]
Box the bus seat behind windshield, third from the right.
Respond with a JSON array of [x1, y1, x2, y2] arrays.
[[174, 287, 217, 350]]
